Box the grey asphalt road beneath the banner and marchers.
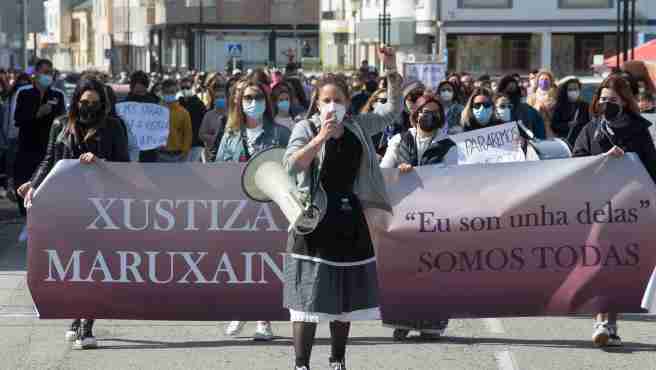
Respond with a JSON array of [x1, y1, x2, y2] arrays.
[[0, 201, 656, 370]]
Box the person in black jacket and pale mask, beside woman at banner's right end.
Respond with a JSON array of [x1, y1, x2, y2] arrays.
[[551, 77, 590, 146]]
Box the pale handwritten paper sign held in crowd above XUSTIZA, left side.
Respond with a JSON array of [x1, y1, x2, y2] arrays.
[[116, 102, 170, 150]]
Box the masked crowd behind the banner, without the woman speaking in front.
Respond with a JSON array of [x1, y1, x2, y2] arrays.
[[0, 55, 656, 362]]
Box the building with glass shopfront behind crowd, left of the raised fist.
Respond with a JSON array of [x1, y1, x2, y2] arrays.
[[149, 0, 319, 71]]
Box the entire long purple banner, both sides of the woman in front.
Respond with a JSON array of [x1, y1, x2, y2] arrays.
[[28, 156, 656, 321]]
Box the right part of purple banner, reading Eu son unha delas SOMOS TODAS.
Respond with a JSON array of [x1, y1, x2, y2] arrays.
[[369, 154, 656, 320]]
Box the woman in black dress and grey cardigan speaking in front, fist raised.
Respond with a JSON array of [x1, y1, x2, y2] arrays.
[[283, 48, 401, 370]]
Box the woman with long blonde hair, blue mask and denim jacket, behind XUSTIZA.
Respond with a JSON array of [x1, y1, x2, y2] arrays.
[[215, 80, 290, 341]]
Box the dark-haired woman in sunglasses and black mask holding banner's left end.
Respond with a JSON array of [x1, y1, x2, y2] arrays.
[[25, 80, 130, 349]]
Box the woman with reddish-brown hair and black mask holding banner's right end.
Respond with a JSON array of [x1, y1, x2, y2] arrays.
[[573, 75, 656, 347]]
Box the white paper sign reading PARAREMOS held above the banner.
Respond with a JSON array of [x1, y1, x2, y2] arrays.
[[451, 122, 526, 164]]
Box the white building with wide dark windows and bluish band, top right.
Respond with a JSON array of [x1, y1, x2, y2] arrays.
[[438, 0, 656, 76]]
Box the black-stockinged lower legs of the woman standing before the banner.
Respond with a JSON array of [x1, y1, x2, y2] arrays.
[[293, 321, 351, 368]]
